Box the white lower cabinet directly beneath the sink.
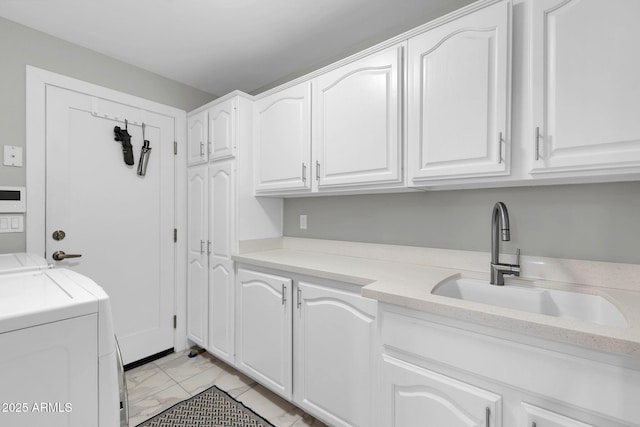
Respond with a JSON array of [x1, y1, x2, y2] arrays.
[[375, 304, 640, 427]]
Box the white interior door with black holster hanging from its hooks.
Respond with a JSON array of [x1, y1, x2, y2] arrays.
[[45, 86, 175, 364]]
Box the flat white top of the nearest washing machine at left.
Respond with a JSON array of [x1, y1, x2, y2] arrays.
[[0, 269, 98, 333]]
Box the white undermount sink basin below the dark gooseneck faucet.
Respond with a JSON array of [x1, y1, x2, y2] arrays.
[[431, 277, 628, 328]]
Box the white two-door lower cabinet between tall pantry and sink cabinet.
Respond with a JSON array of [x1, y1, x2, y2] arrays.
[[236, 266, 377, 427]]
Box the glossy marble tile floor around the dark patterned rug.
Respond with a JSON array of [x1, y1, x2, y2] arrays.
[[126, 350, 326, 427]]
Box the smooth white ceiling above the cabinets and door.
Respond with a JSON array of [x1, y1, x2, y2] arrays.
[[0, 0, 472, 95]]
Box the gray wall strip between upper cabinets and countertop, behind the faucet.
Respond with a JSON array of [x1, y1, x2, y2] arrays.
[[284, 182, 640, 264]]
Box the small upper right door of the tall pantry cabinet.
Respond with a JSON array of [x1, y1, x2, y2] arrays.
[[207, 98, 238, 160]]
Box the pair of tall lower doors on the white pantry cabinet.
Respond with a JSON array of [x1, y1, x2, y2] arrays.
[[187, 160, 235, 363]]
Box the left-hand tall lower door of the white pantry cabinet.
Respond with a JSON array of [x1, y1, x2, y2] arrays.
[[187, 165, 208, 347]]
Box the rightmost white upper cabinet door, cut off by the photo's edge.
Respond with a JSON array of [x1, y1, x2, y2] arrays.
[[530, 0, 640, 173]]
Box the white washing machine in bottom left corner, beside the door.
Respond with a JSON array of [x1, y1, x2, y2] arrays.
[[0, 254, 128, 427]]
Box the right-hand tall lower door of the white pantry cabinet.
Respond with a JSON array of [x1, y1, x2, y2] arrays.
[[207, 161, 235, 362]]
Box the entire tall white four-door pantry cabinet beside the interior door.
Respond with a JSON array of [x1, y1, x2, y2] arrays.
[[187, 91, 282, 364]]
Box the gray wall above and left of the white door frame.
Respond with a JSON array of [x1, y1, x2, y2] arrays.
[[0, 18, 215, 253]]
